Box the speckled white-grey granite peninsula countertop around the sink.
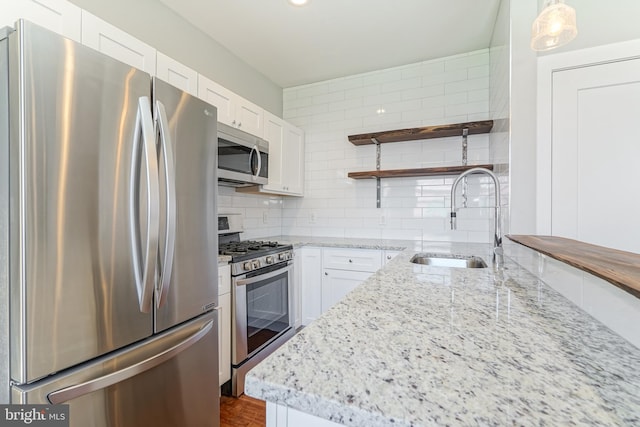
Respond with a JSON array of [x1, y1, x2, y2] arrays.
[[245, 242, 640, 427]]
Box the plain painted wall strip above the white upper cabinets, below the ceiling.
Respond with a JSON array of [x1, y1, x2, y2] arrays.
[[71, 0, 282, 116]]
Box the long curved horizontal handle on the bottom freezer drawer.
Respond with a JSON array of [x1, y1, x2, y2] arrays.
[[47, 321, 213, 405]]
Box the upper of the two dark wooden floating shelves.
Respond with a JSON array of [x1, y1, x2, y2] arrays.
[[348, 120, 493, 145]]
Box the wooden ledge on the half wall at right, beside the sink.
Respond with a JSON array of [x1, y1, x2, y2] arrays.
[[507, 235, 640, 298]]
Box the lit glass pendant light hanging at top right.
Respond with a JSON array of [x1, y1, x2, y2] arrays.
[[531, 0, 578, 51]]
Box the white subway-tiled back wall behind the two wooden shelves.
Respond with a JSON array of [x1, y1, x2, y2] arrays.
[[282, 49, 493, 242]]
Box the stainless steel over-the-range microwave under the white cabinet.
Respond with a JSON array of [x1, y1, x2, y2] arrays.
[[218, 122, 269, 186]]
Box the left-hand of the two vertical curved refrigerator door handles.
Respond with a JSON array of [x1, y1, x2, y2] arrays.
[[129, 96, 160, 313]]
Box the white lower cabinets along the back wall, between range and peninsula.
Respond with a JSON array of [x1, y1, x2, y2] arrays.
[[300, 247, 382, 325]]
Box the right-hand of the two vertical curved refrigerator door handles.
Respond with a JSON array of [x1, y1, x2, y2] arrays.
[[156, 101, 177, 308]]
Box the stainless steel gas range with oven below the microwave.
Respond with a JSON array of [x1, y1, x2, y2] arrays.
[[218, 215, 295, 396]]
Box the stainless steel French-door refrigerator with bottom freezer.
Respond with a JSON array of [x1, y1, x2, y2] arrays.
[[0, 21, 219, 427]]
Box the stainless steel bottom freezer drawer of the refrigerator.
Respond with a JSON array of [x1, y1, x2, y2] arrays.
[[12, 312, 219, 427]]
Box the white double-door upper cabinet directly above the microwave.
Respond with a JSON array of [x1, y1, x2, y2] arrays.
[[198, 75, 264, 138]]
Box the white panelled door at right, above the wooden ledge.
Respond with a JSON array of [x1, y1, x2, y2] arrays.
[[551, 59, 640, 253]]
